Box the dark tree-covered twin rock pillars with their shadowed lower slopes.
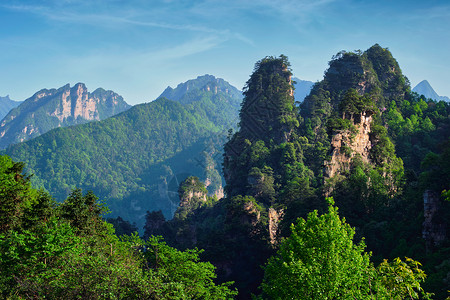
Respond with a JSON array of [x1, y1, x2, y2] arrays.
[[146, 45, 450, 299]]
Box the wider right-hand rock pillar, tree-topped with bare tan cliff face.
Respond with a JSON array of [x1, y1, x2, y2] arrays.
[[300, 45, 410, 199]]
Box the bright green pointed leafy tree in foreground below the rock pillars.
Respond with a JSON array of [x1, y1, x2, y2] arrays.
[[262, 198, 371, 299]]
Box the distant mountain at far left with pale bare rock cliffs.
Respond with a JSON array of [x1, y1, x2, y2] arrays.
[[0, 83, 130, 149]]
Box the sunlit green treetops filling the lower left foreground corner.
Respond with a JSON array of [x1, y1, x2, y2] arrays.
[[0, 156, 237, 299]]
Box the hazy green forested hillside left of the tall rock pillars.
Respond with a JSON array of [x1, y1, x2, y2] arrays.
[[5, 78, 241, 226]]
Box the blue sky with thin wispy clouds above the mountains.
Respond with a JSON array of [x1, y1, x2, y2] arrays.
[[0, 0, 450, 105]]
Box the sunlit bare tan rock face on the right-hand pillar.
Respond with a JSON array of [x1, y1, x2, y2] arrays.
[[324, 112, 372, 179]]
